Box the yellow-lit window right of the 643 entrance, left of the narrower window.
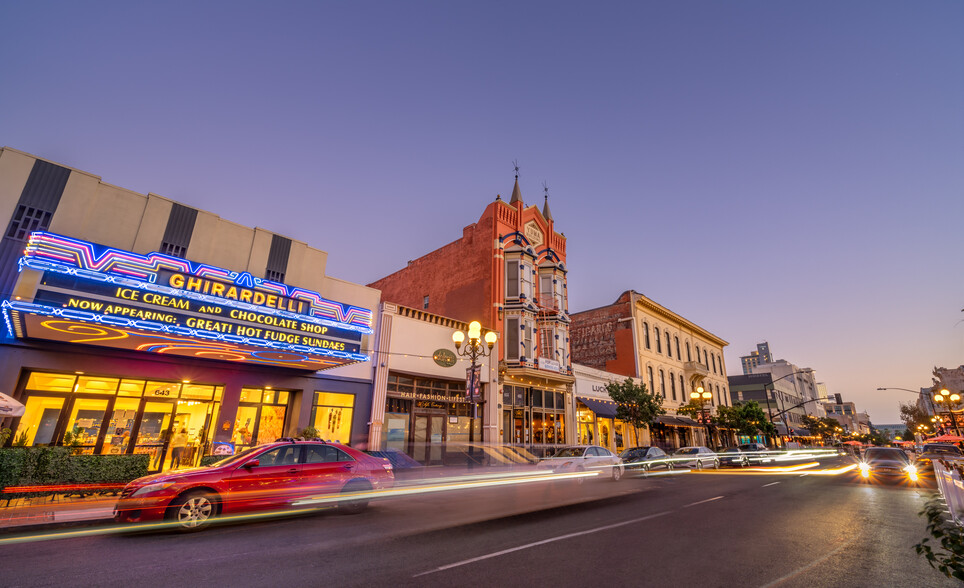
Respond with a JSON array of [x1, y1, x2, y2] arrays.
[[231, 388, 290, 452]]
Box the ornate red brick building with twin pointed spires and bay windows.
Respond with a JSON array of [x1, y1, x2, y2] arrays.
[[370, 176, 574, 444]]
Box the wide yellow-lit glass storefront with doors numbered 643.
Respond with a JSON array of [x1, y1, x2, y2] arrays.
[[14, 372, 222, 471]]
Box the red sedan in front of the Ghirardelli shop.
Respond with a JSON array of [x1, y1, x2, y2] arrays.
[[114, 439, 394, 530]]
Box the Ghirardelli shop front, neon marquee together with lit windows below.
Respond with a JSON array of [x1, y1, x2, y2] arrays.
[[0, 233, 371, 471]]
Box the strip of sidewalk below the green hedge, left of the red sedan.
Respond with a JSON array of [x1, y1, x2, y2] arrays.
[[0, 494, 117, 533]]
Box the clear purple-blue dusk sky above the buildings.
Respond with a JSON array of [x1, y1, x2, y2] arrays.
[[0, 0, 964, 424]]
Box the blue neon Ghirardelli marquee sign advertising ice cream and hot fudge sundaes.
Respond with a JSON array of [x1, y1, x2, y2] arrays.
[[2, 232, 372, 371]]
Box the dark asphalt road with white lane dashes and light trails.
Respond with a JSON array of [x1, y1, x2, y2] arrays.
[[0, 459, 959, 588]]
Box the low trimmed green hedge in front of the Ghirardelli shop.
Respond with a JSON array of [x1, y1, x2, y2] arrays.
[[0, 447, 150, 500]]
